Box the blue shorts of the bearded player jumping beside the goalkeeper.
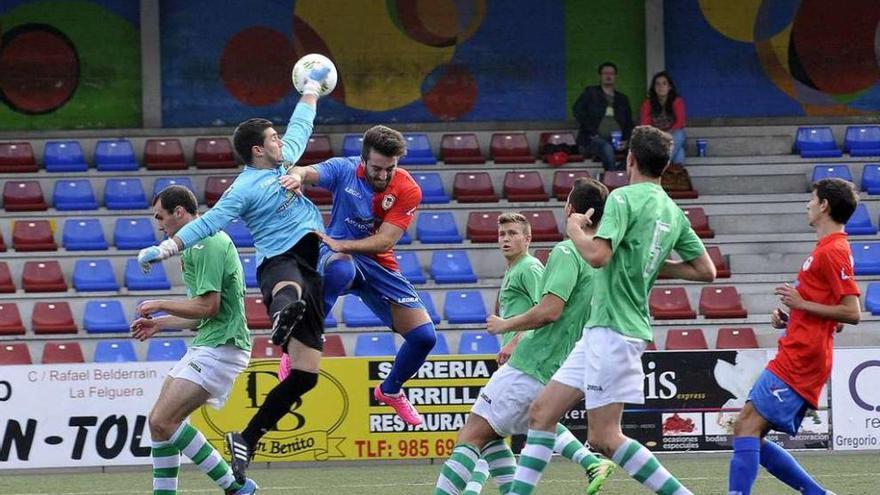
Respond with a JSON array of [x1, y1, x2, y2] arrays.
[[318, 243, 427, 329]]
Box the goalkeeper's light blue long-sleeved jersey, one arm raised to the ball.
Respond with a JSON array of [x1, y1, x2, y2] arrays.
[[176, 103, 324, 266]]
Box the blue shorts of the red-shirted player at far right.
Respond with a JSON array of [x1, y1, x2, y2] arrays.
[[748, 369, 810, 435]]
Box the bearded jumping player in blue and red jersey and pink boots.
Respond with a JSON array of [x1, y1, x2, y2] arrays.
[[281, 125, 437, 425]]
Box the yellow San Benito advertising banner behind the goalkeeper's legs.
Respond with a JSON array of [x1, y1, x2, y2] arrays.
[[192, 355, 498, 462]]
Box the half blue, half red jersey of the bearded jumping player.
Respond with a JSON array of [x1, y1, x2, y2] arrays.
[[314, 157, 422, 271]]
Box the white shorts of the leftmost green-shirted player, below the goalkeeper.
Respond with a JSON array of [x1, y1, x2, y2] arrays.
[[168, 344, 251, 409]]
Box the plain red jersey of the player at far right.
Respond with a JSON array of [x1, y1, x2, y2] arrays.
[[767, 232, 859, 408]]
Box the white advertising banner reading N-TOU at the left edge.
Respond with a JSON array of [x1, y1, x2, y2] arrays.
[[0, 362, 174, 470]]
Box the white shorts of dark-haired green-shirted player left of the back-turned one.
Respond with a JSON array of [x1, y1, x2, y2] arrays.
[[471, 364, 544, 437]]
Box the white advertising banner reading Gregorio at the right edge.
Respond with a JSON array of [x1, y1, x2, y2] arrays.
[[831, 349, 880, 450]]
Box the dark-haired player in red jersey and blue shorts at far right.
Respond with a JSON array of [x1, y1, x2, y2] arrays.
[[728, 179, 861, 495]]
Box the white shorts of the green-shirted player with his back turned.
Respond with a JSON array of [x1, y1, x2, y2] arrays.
[[552, 327, 648, 410]]
